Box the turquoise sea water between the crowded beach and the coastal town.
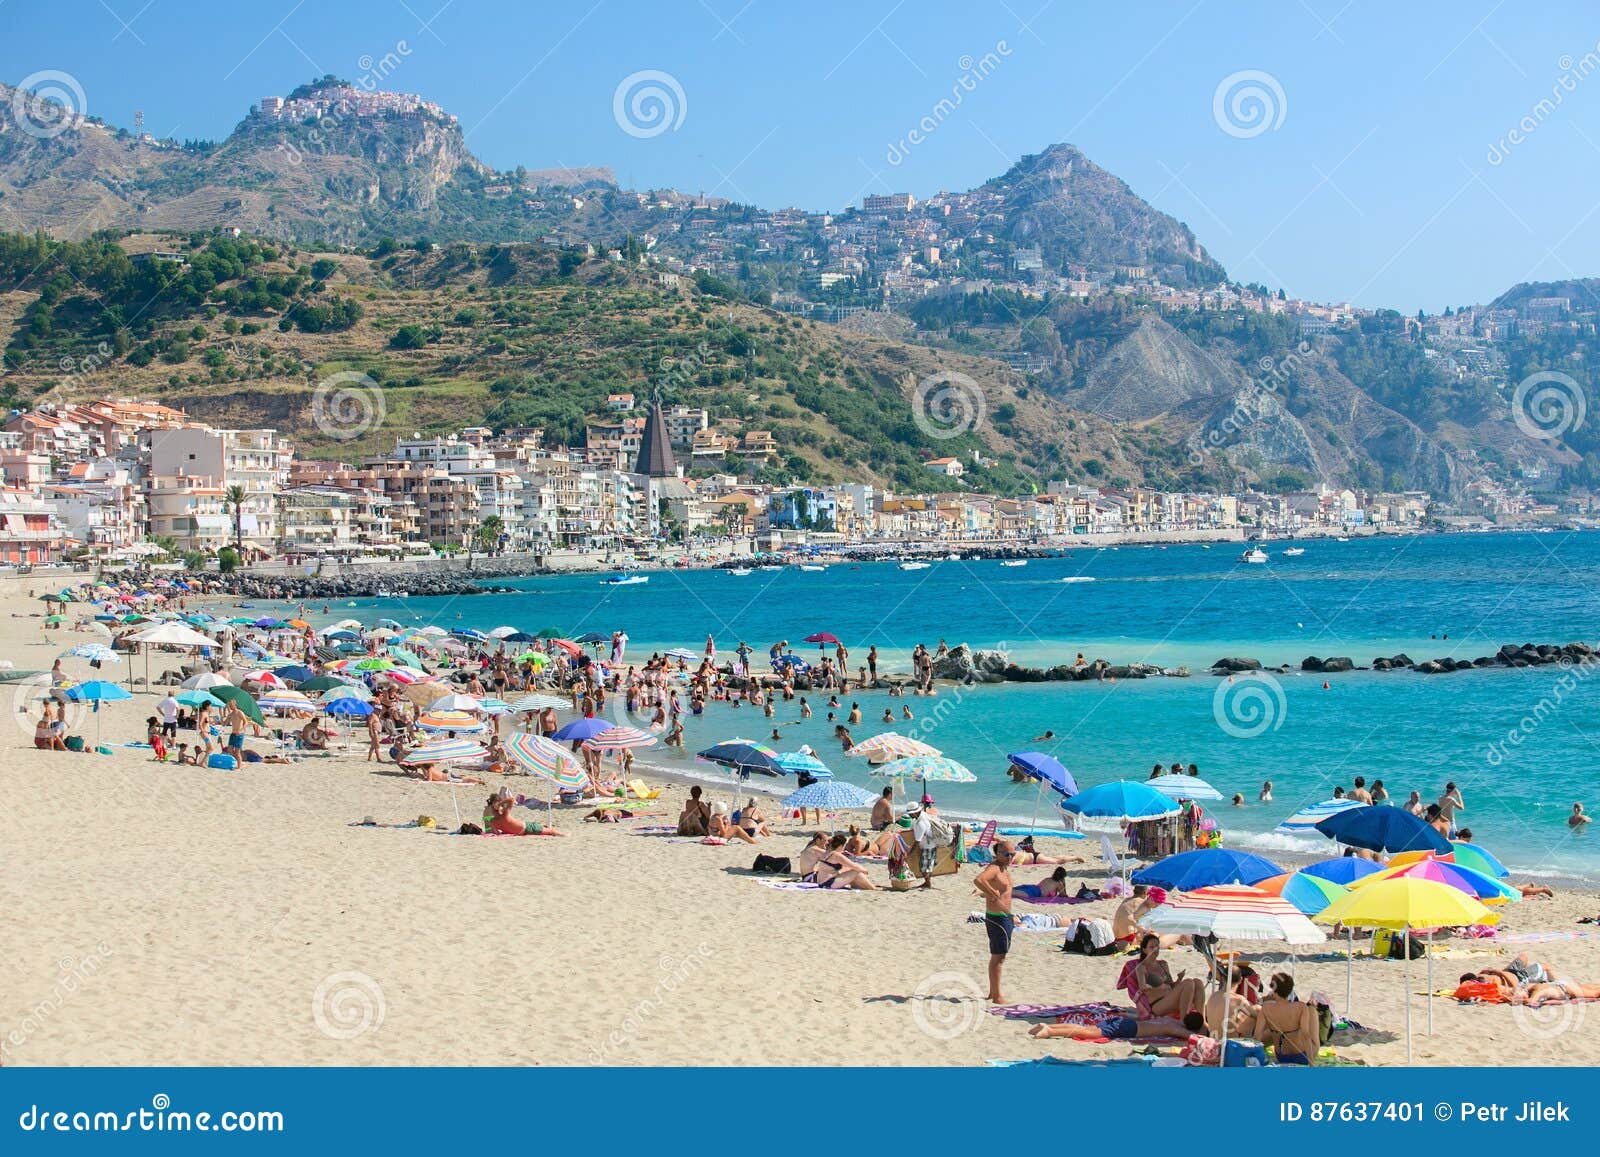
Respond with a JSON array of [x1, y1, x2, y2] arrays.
[[297, 533, 1600, 879]]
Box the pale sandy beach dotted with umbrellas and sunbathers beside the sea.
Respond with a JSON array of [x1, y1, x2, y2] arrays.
[[9, 583, 1600, 1066]]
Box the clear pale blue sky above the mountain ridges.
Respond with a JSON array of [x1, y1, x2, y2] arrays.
[[0, 0, 1600, 312]]
